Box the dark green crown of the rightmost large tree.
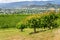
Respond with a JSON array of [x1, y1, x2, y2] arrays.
[[41, 14, 58, 29]]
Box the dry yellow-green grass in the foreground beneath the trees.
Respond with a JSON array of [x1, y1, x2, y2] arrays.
[[0, 28, 55, 40]]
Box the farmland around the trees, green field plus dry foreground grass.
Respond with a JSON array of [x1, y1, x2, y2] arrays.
[[0, 11, 60, 40]]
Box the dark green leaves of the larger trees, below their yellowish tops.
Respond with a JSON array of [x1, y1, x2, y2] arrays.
[[28, 13, 58, 29]]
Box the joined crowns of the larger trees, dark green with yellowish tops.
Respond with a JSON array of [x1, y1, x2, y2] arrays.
[[26, 12, 58, 31]]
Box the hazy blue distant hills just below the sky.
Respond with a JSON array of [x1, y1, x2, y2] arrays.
[[0, 1, 60, 8]]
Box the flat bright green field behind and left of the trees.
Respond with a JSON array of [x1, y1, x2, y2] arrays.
[[0, 14, 27, 29]]
